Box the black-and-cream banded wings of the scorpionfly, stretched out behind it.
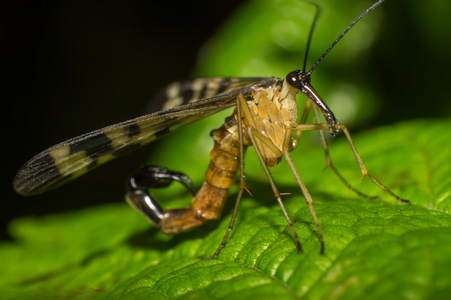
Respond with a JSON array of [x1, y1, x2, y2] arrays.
[[13, 77, 281, 195]]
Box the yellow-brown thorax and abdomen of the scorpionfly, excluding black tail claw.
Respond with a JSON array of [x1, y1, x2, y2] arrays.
[[161, 81, 297, 234]]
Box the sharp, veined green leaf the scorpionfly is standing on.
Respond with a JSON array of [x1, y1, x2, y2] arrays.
[[0, 120, 451, 299]]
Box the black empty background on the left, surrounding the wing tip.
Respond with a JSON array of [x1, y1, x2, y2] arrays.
[[0, 0, 244, 238]]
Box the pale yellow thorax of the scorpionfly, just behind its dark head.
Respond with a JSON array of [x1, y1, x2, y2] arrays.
[[243, 81, 297, 167]]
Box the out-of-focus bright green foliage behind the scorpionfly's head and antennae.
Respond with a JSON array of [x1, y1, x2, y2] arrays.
[[195, 0, 382, 126]]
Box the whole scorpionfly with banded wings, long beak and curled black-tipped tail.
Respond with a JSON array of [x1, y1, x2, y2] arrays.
[[13, 0, 410, 258]]
